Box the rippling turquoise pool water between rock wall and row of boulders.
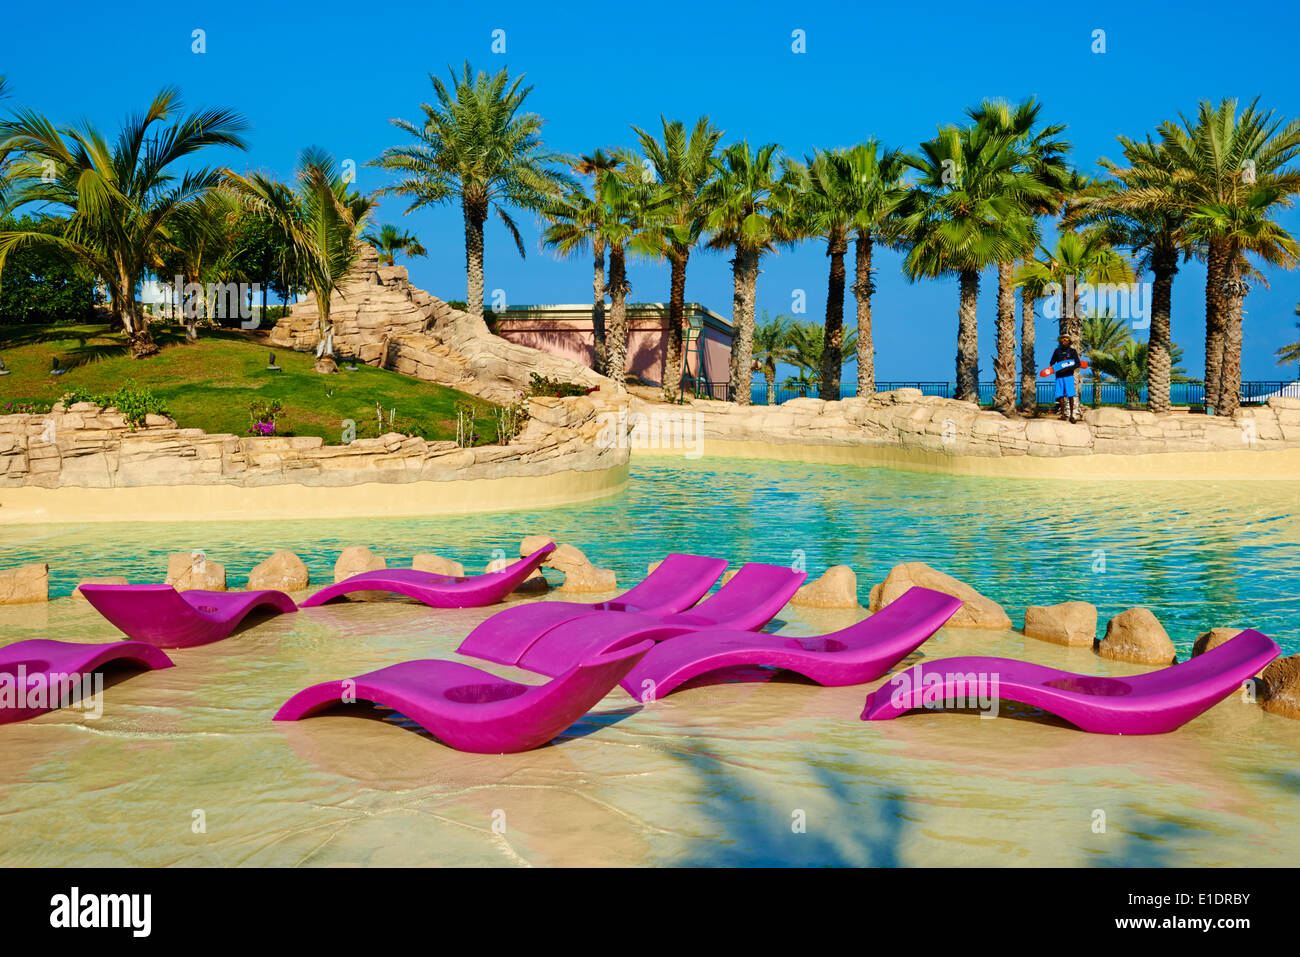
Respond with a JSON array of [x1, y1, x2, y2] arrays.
[[0, 459, 1300, 655]]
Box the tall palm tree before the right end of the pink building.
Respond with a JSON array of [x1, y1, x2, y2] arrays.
[[632, 116, 723, 385]]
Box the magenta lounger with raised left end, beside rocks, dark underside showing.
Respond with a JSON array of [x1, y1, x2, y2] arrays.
[[81, 585, 298, 648]]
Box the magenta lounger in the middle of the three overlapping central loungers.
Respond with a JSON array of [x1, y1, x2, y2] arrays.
[[501, 563, 806, 675]]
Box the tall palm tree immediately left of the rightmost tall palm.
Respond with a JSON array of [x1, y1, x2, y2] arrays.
[[1063, 137, 1192, 412]]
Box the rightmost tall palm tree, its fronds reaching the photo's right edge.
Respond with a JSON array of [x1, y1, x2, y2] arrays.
[[1160, 99, 1300, 415]]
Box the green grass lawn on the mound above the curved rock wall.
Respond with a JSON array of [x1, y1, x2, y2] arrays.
[[0, 324, 497, 445]]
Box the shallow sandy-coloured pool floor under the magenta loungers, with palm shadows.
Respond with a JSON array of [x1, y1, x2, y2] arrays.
[[0, 598, 1300, 866]]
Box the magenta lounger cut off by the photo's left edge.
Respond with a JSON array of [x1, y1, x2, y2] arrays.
[[0, 638, 172, 724]]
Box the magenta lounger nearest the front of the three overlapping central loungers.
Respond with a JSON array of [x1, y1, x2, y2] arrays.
[[621, 586, 962, 701]]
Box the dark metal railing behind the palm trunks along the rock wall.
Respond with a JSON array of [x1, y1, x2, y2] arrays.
[[743, 378, 1300, 406]]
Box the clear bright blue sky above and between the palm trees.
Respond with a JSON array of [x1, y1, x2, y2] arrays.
[[0, 0, 1300, 380]]
